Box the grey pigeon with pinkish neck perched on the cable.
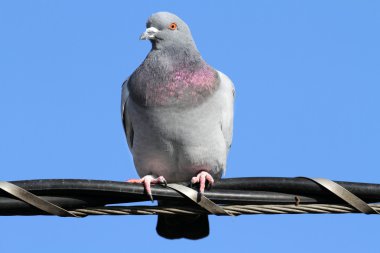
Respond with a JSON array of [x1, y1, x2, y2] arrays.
[[121, 12, 235, 239]]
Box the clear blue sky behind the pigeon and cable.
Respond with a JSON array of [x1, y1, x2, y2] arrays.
[[0, 0, 380, 252]]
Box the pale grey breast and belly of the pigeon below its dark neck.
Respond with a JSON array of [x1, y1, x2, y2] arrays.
[[127, 71, 228, 182]]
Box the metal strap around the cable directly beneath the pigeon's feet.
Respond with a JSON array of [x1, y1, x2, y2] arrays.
[[167, 184, 233, 216]]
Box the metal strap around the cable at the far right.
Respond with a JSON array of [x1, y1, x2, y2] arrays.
[[299, 177, 380, 214]]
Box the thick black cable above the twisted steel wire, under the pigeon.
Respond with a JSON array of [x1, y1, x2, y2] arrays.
[[0, 177, 380, 215]]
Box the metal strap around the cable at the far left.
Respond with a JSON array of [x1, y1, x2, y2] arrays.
[[0, 181, 82, 218]]
